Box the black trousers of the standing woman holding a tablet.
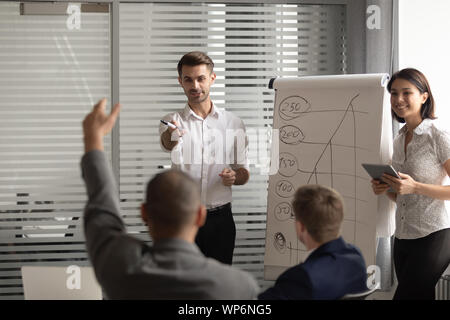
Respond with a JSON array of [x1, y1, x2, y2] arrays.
[[394, 229, 450, 300]]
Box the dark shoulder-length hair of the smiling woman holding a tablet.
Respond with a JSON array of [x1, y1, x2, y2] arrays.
[[387, 68, 436, 123]]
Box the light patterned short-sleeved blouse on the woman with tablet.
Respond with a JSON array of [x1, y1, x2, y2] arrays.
[[392, 119, 450, 239]]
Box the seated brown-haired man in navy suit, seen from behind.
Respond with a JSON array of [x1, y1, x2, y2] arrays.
[[258, 185, 367, 300]]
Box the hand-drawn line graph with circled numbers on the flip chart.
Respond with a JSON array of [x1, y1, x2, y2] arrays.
[[272, 93, 369, 263]]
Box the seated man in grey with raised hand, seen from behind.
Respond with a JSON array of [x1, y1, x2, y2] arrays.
[[81, 99, 259, 299]]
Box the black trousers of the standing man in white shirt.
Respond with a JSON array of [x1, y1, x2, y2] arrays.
[[195, 203, 236, 265]]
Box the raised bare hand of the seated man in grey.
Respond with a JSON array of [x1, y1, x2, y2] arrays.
[[83, 98, 120, 152]]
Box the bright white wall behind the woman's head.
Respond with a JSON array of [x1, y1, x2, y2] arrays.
[[399, 0, 450, 124]]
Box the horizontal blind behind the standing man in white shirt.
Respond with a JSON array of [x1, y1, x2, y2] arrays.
[[120, 3, 346, 288]]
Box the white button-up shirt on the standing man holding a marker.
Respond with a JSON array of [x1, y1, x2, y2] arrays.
[[159, 103, 249, 209]]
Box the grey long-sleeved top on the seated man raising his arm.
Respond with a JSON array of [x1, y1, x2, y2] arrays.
[[81, 150, 259, 299]]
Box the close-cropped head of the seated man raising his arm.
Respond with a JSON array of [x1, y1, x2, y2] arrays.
[[145, 170, 200, 234]]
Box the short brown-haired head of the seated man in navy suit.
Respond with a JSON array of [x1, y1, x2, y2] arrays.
[[292, 185, 344, 243]]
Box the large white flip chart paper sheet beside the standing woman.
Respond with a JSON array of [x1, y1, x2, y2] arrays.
[[264, 74, 393, 279]]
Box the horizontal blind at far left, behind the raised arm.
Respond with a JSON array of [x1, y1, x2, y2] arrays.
[[0, 1, 111, 299]]
